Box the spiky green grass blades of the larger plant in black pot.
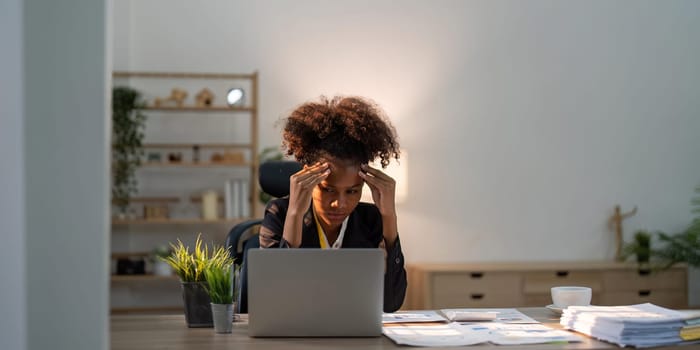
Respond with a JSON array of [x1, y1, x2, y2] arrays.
[[161, 234, 233, 282]]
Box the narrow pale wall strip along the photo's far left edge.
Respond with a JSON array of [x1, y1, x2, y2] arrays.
[[0, 0, 28, 349]]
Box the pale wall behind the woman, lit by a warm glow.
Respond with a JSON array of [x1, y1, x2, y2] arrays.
[[115, 0, 700, 298]]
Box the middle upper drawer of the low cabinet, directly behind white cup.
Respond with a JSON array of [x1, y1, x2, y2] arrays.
[[523, 270, 602, 295]]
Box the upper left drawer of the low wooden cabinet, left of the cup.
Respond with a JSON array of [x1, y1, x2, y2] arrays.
[[433, 271, 521, 294]]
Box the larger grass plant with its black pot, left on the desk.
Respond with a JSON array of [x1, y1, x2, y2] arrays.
[[163, 234, 231, 328]]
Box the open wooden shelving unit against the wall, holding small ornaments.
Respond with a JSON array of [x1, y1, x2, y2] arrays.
[[110, 71, 258, 313]]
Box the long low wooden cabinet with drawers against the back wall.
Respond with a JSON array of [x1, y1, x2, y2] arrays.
[[403, 262, 688, 310]]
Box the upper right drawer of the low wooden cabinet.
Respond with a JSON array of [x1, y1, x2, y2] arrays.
[[603, 269, 687, 292]]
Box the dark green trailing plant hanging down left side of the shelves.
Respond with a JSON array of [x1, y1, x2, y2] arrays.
[[112, 87, 146, 216]]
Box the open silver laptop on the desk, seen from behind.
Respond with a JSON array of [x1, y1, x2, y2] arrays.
[[247, 248, 384, 337]]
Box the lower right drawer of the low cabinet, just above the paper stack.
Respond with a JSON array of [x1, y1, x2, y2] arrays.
[[600, 290, 688, 309]]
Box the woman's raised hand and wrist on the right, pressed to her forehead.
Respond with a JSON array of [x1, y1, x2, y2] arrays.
[[359, 164, 399, 246]]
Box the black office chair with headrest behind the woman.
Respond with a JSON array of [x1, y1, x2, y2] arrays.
[[225, 160, 302, 313]]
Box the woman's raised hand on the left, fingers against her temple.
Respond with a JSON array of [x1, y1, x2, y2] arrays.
[[289, 163, 331, 215]]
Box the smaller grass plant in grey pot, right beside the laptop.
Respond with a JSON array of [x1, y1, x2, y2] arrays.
[[204, 266, 234, 333]]
